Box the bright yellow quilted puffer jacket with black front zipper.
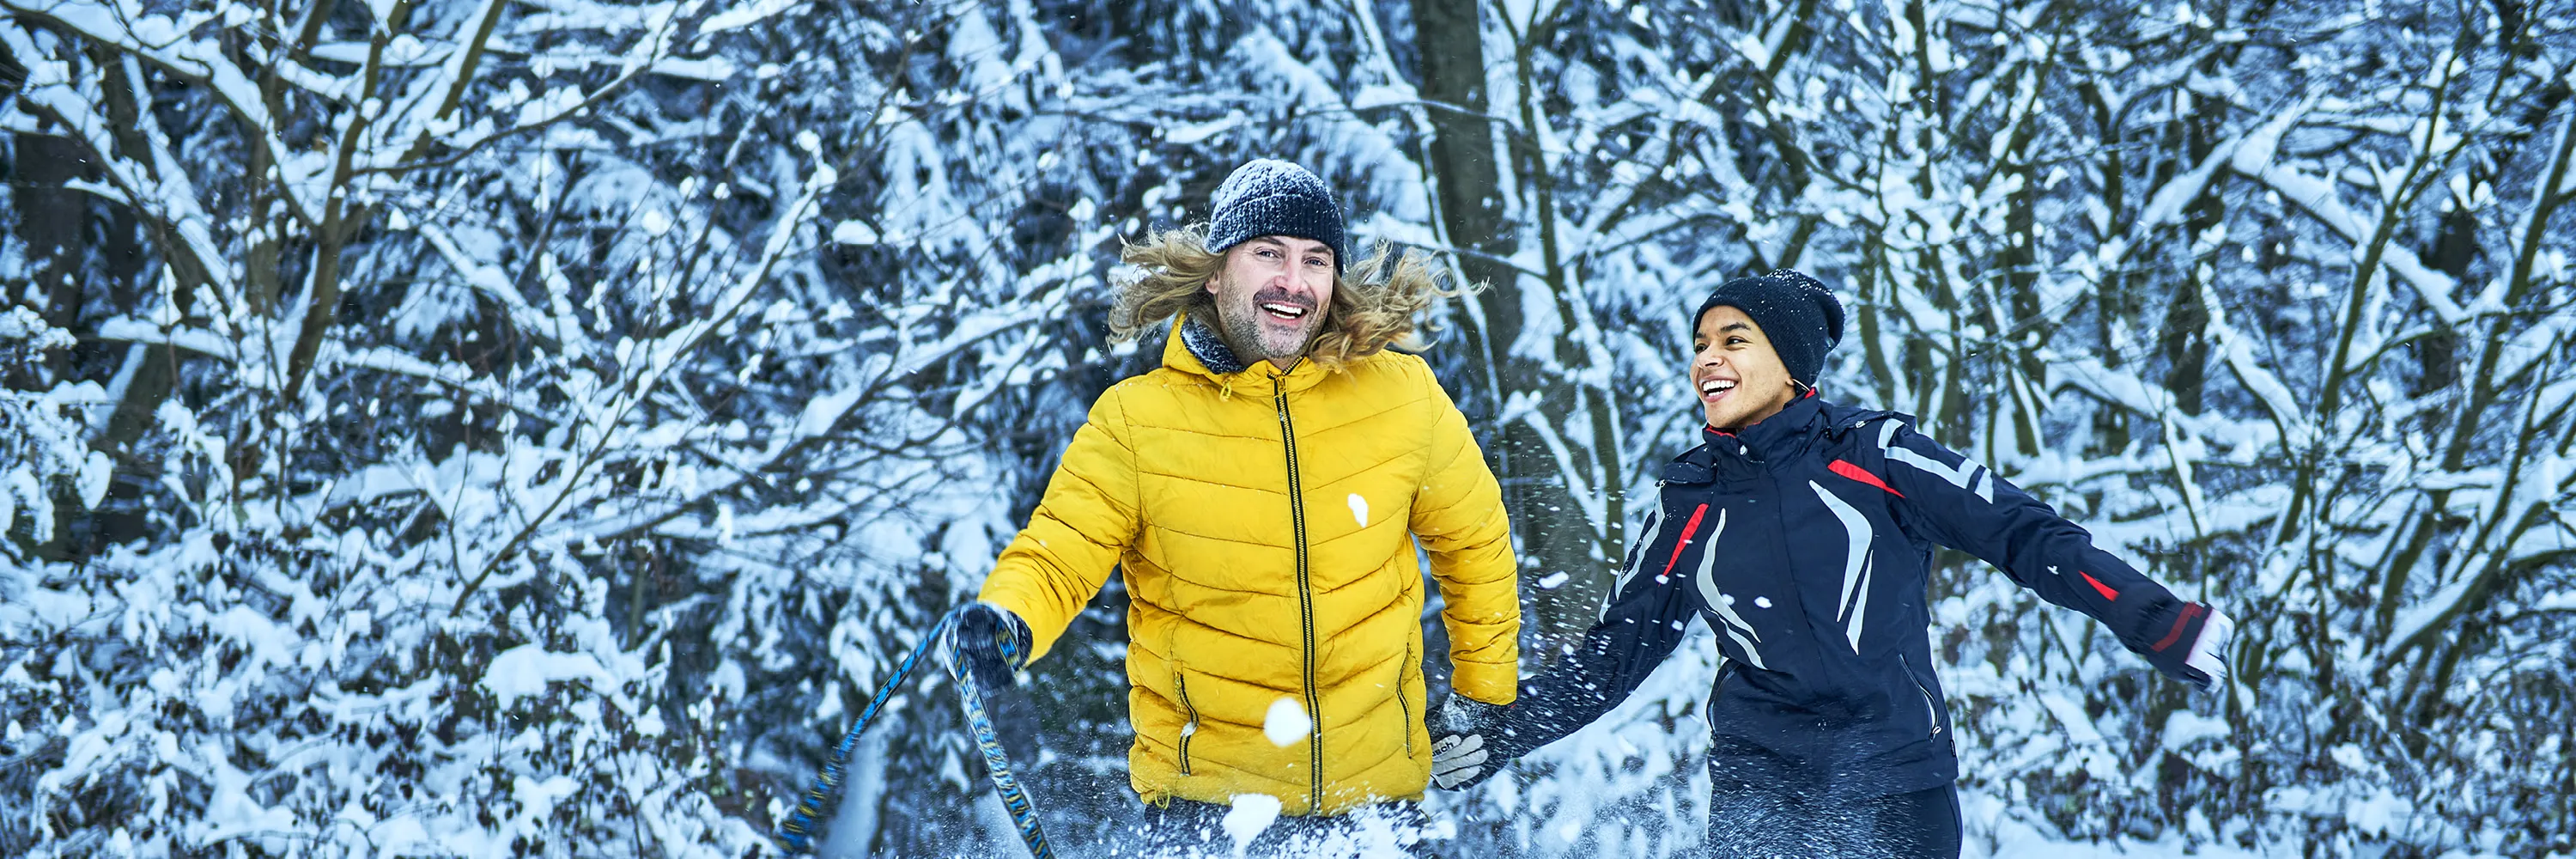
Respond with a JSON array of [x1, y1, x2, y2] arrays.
[[981, 325, 1520, 815]]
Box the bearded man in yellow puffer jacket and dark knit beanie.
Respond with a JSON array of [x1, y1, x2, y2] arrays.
[[961, 160, 1520, 854]]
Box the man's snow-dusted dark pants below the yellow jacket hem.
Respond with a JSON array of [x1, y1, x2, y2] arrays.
[[1110, 800, 1432, 859]]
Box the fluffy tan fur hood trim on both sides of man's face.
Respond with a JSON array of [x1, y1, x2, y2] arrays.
[[1110, 224, 1476, 371]]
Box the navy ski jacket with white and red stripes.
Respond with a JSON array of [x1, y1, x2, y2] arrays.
[[1486, 397, 2208, 797]]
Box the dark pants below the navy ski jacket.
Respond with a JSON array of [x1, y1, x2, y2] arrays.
[[1708, 784, 1960, 859]]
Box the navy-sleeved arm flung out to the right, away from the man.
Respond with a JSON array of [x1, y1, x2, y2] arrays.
[[1865, 420, 2231, 684]]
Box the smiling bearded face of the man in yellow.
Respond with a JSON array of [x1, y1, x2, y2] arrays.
[[1208, 235, 1332, 369]]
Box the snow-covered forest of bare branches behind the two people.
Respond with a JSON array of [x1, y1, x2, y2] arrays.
[[0, 0, 2576, 856]]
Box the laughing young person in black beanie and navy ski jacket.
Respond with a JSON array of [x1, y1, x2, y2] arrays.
[[1430, 271, 2233, 856]]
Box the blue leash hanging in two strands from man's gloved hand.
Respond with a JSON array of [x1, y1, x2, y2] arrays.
[[773, 604, 1056, 859]]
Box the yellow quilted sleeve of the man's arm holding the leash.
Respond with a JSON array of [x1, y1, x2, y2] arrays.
[[981, 387, 1139, 661]]
